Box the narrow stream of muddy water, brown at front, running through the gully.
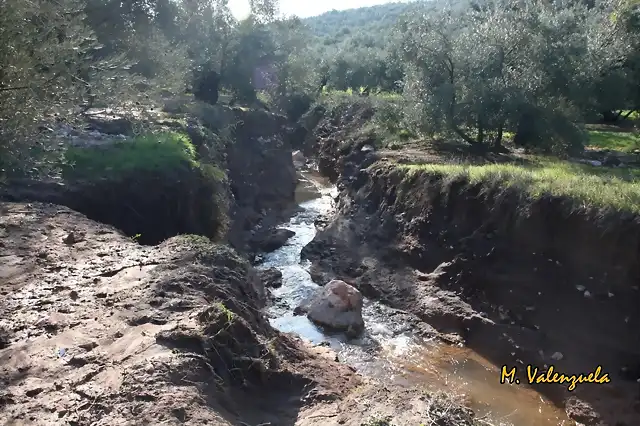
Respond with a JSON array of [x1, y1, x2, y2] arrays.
[[260, 173, 573, 426]]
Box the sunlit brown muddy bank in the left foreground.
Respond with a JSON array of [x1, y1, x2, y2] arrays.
[[0, 202, 360, 425]]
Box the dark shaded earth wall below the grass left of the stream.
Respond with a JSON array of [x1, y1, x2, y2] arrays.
[[0, 107, 297, 252]]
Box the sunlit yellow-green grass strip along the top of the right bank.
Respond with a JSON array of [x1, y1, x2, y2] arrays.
[[401, 157, 640, 214]]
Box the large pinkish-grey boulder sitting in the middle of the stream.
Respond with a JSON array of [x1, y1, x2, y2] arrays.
[[305, 280, 364, 337]]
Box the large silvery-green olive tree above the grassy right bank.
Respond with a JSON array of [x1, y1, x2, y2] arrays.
[[401, 0, 629, 153]]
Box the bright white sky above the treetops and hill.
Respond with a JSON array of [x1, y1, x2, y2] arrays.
[[229, 0, 397, 19]]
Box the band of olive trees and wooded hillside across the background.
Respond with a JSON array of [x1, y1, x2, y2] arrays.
[[0, 0, 640, 173]]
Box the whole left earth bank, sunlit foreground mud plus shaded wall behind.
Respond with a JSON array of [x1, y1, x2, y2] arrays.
[[0, 103, 478, 426]]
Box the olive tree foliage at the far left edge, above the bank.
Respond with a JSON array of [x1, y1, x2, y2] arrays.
[[0, 0, 131, 174]]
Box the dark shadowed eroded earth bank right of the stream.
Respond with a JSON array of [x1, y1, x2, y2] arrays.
[[303, 103, 640, 425]]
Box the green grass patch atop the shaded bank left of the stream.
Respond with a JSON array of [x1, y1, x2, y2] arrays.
[[62, 132, 205, 179]]
